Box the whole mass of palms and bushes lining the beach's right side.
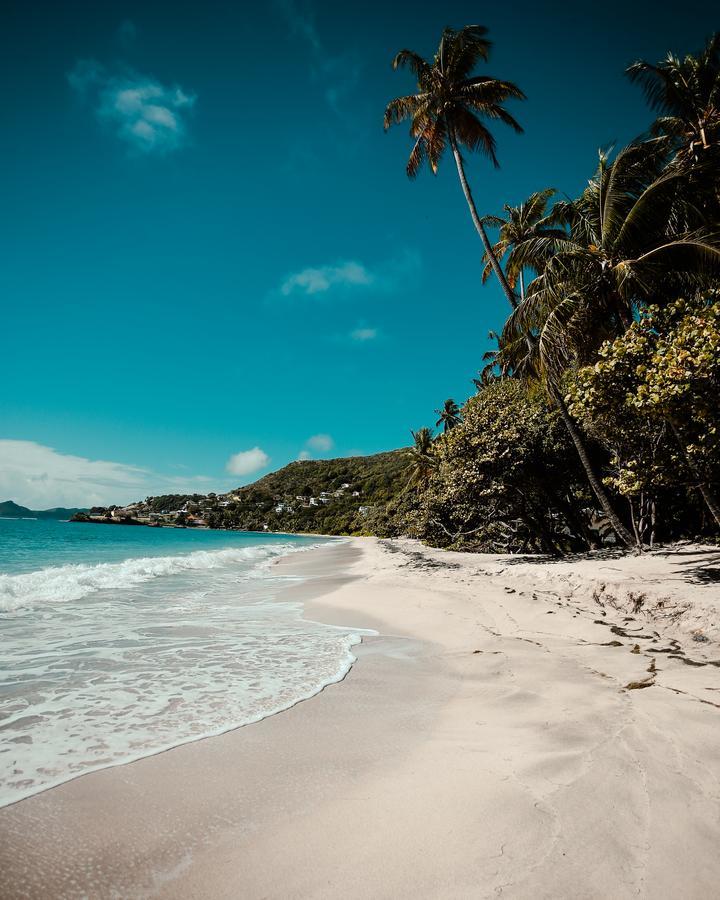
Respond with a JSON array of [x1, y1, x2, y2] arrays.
[[376, 25, 720, 553]]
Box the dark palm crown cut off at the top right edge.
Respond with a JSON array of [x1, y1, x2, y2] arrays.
[[626, 33, 720, 159]]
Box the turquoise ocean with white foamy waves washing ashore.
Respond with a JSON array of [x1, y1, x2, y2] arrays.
[[0, 519, 360, 806]]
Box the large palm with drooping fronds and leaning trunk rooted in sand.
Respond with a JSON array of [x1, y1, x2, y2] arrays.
[[500, 146, 720, 546]]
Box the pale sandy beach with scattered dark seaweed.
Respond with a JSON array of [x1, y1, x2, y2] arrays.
[[0, 539, 720, 900]]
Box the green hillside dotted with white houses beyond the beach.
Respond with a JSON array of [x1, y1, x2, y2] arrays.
[[75, 450, 408, 534]]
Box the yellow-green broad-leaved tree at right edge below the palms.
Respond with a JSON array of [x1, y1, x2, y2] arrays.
[[568, 297, 720, 543]]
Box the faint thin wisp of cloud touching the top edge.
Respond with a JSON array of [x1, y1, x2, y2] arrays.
[[275, 0, 362, 114]]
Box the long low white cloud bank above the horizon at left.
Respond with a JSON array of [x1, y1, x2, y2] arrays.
[[0, 439, 211, 509]]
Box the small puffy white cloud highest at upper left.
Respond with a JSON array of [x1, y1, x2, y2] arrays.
[[68, 60, 196, 156]]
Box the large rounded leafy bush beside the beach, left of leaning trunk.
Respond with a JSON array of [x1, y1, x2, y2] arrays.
[[374, 380, 588, 553]]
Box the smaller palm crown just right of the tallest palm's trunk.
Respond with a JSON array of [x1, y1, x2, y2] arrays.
[[482, 188, 567, 303]]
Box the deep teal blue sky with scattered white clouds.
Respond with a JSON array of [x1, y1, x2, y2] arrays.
[[0, 0, 718, 508]]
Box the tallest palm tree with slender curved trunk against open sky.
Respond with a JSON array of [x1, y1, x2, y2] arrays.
[[385, 25, 525, 308]]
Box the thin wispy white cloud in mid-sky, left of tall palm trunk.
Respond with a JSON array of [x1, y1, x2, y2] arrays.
[[280, 251, 421, 297]]
